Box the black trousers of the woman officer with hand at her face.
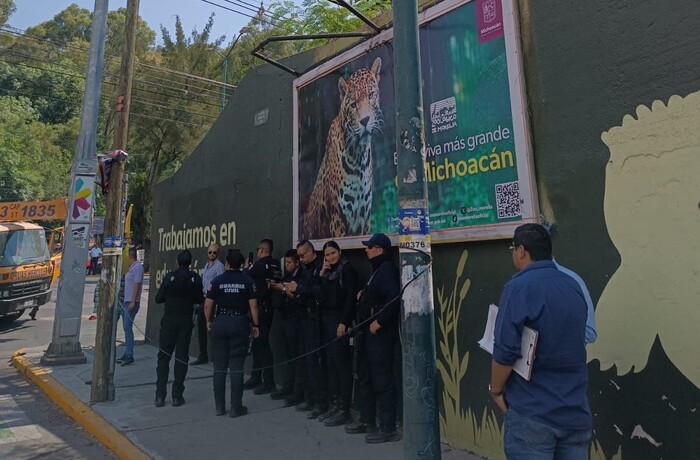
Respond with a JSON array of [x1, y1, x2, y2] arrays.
[[321, 311, 352, 410]]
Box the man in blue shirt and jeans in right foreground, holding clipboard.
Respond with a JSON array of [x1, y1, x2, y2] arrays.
[[489, 224, 592, 460]]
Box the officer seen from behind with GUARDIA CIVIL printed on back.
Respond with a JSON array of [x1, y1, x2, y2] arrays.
[[204, 249, 260, 417]]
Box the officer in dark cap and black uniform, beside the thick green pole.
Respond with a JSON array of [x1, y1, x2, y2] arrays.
[[360, 233, 401, 444]]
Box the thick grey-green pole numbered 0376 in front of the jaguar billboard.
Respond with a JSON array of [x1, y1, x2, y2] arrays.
[[392, 0, 440, 459]]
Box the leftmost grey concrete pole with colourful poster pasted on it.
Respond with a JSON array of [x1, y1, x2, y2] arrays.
[[41, 0, 109, 365]]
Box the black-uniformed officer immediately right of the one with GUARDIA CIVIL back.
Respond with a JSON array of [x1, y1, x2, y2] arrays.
[[243, 238, 282, 395]]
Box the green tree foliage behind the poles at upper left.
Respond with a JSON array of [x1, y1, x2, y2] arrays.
[[0, 0, 391, 241]]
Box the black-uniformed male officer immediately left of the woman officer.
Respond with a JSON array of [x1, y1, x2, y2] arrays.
[[287, 240, 328, 419]]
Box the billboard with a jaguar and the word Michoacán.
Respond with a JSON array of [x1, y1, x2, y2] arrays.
[[295, 0, 535, 246]]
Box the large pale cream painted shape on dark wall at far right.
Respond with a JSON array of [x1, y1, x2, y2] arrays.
[[589, 91, 700, 388]]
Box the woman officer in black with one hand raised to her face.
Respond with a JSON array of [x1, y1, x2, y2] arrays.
[[318, 240, 358, 426]]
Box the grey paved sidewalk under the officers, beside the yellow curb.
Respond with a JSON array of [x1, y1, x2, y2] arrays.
[[17, 344, 480, 460]]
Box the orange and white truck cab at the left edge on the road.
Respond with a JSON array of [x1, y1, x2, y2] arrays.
[[0, 222, 54, 321]]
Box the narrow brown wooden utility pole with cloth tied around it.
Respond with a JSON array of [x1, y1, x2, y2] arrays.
[[90, 0, 139, 403]]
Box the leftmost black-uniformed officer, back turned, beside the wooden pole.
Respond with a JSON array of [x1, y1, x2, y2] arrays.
[[155, 250, 204, 407]]
